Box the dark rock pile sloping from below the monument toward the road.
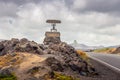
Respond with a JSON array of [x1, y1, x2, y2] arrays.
[[45, 42, 95, 76]]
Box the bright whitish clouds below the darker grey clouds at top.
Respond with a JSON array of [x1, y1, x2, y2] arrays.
[[0, 0, 120, 45]]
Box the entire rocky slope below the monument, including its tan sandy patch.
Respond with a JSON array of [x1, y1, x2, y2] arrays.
[[0, 38, 96, 80]]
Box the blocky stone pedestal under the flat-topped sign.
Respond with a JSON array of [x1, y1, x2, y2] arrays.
[[43, 32, 61, 45]]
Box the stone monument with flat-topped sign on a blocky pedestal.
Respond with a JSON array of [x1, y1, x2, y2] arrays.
[[43, 20, 61, 45]]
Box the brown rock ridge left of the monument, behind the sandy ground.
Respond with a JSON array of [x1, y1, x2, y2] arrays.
[[0, 38, 43, 55]]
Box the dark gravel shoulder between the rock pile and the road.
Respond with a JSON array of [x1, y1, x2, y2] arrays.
[[80, 60, 120, 80]]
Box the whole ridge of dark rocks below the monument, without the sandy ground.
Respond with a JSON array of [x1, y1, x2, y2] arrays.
[[0, 38, 96, 80]]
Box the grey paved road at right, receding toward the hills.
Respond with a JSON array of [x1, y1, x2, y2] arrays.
[[88, 53, 120, 69]]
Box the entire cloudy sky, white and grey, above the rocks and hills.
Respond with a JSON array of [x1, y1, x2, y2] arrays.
[[0, 0, 120, 46]]
